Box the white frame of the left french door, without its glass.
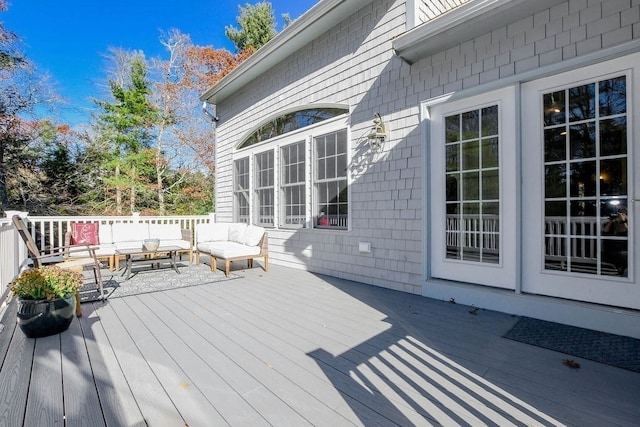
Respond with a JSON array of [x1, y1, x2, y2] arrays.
[[424, 86, 519, 290]]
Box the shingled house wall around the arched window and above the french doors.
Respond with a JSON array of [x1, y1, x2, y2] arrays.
[[216, 0, 640, 293]]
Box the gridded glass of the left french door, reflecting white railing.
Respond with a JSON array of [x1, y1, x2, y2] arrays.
[[445, 105, 500, 264]]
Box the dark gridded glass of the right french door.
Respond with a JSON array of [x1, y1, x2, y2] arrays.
[[543, 76, 633, 277]]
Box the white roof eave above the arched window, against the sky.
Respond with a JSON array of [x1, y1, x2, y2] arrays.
[[200, 0, 371, 104]]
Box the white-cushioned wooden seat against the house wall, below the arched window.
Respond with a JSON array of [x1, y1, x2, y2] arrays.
[[195, 223, 269, 277]]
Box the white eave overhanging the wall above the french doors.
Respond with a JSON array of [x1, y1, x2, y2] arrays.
[[393, 0, 566, 63]]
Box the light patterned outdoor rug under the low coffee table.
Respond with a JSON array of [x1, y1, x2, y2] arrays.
[[80, 263, 240, 303]]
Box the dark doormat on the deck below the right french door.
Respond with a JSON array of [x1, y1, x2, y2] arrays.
[[504, 317, 640, 372]]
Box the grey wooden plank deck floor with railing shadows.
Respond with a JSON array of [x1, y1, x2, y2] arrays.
[[0, 265, 640, 427]]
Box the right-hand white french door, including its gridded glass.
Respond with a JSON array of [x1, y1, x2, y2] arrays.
[[522, 55, 640, 309]]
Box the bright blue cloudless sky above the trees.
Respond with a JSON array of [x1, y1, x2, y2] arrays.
[[0, 0, 317, 125]]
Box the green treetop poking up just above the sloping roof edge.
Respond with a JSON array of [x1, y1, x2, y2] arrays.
[[225, 1, 276, 52]]
